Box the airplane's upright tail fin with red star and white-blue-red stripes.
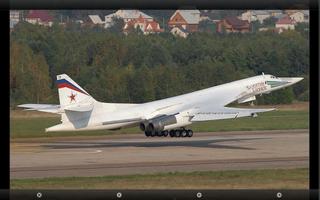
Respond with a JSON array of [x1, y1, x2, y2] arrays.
[[57, 74, 95, 108]]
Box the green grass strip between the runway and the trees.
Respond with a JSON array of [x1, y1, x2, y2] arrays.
[[10, 110, 309, 139]]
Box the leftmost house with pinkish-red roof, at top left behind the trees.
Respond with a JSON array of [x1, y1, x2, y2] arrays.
[[25, 10, 54, 26]]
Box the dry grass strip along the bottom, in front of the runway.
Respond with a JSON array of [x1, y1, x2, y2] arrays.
[[10, 168, 309, 189]]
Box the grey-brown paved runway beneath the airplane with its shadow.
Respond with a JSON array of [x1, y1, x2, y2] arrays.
[[10, 129, 309, 179]]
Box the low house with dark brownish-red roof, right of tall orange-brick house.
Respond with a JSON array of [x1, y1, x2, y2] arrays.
[[217, 17, 250, 33]]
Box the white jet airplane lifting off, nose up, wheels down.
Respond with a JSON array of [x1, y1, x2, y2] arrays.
[[18, 73, 303, 137]]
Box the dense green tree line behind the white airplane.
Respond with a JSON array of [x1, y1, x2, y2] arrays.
[[10, 22, 309, 107]]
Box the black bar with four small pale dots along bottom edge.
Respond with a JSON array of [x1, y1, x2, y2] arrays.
[[0, 190, 319, 200]]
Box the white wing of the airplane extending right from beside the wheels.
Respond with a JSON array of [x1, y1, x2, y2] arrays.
[[191, 107, 275, 122]]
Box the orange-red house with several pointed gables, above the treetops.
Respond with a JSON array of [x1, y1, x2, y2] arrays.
[[123, 15, 164, 35]]
